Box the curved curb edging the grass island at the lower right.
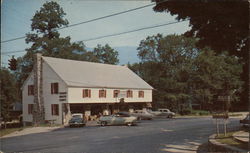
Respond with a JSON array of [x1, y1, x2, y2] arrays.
[[208, 134, 248, 153]]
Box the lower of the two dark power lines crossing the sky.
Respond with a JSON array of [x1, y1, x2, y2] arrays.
[[2, 19, 187, 55]]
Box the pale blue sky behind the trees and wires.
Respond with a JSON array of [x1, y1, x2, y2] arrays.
[[1, 0, 190, 66]]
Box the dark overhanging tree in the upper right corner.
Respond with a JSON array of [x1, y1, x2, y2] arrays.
[[154, 0, 249, 109]]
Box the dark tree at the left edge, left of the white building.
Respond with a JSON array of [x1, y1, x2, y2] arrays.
[[0, 69, 18, 126]]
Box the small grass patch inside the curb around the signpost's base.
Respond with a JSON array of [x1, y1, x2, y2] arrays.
[[216, 132, 248, 150]]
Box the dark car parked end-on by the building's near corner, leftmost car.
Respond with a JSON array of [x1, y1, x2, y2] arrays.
[[69, 113, 86, 127]]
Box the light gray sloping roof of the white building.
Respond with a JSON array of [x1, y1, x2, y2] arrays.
[[43, 56, 153, 89]]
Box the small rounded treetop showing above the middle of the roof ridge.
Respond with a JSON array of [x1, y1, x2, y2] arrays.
[[93, 44, 119, 64]]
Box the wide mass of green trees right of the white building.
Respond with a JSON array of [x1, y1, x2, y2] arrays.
[[130, 34, 242, 111]]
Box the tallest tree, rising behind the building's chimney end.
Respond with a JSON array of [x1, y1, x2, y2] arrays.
[[16, 1, 90, 87]]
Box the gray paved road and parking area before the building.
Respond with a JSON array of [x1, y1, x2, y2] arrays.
[[1, 117, 239, 153]]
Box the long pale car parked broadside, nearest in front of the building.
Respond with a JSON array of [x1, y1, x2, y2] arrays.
[[98, 112, 137, 126]]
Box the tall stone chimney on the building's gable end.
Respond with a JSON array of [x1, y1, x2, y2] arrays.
[[33, 53, 45, 126]]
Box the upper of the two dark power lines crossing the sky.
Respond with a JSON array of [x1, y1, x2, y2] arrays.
[[1, 4, 155, 43]]
